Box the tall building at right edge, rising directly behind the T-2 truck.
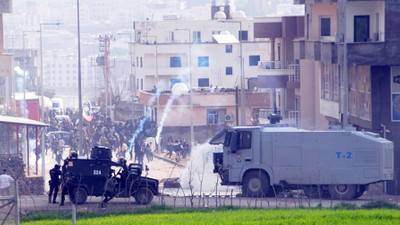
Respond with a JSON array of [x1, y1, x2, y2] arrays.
[[295, 0, 400, 194]]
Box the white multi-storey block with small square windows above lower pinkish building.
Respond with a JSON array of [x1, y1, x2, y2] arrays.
[[131, 19, 270, 93]]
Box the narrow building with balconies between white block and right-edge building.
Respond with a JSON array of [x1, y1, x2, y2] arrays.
[[249, 16, 304, 127]]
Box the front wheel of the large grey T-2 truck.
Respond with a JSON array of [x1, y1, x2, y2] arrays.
[[242, 171, 270, 197]]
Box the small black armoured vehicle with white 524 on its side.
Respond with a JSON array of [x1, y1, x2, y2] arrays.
[[64, 146, 159, 204]]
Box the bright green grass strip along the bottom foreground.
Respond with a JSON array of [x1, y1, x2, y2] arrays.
[[22, 208, 400, 225]]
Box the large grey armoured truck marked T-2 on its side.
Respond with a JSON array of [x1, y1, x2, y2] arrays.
[[210, 126, 394, 200]]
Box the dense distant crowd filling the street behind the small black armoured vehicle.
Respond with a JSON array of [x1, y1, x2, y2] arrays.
[[46, 106, 190, 165]]
